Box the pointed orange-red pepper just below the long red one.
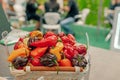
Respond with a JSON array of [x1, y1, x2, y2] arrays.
[[30, 47, 48, 58]]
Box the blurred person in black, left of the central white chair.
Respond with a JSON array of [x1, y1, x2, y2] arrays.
[[26, 0, 40, 30]]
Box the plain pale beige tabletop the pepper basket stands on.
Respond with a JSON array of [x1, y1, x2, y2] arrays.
[[0, 45, 120, 80]]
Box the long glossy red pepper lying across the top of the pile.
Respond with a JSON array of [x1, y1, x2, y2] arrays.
[[30, 35, 57, 47]]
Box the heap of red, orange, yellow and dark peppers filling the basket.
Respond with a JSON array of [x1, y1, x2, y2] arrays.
[[8, 31, 87, 69]]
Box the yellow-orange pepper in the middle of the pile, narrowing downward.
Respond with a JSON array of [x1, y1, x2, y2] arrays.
[[50, 42, 64, 62]]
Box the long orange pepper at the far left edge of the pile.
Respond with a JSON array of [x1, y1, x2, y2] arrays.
[[8, 48, 29, 62]]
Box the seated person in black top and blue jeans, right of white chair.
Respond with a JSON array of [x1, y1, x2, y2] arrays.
[[60, 0, 79, 35]]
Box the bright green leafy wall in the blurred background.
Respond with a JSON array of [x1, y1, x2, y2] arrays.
[[76, 0, 110, 27]]
